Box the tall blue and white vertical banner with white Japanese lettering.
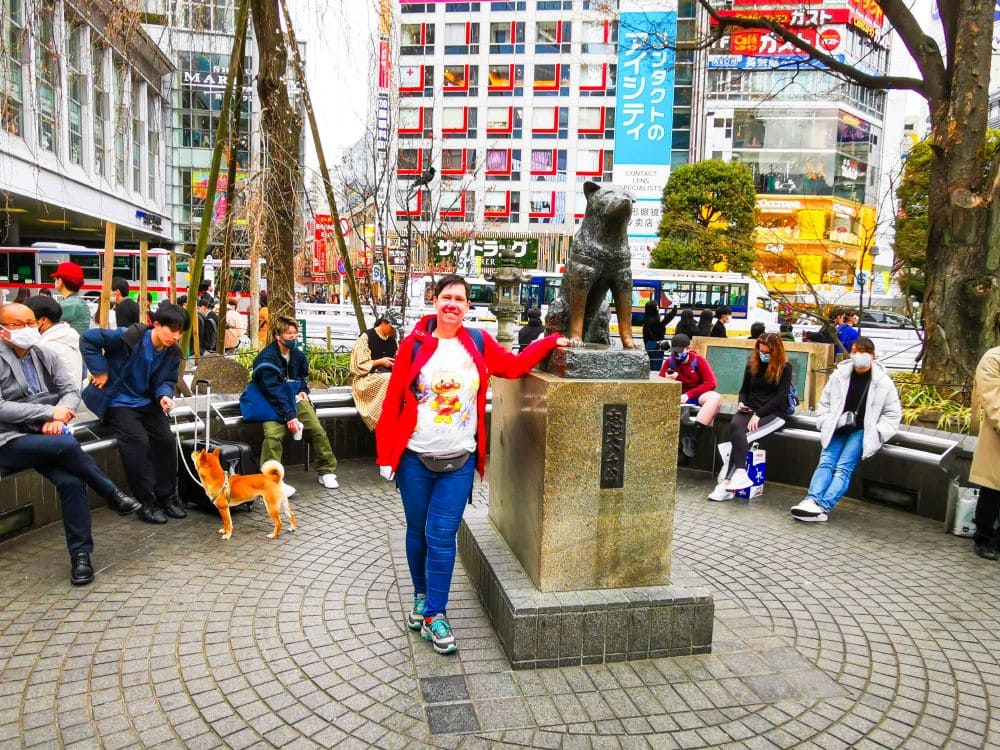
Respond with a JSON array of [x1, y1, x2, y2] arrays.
[[613, 0, 677, 265]]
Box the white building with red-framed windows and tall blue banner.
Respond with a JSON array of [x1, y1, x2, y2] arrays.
[[389, 0, 696, 271]]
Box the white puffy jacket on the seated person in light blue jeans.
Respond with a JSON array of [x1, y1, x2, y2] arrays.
[[816, 359, 903, 459]]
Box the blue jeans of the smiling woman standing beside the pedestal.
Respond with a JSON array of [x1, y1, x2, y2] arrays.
[[396, 450, 476, 617]]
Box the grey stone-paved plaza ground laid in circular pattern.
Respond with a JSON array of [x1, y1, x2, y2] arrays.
[[0, 461, 1000, 748]]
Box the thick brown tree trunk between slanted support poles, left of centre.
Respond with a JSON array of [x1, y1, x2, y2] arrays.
[[251, 0, 302, 320]]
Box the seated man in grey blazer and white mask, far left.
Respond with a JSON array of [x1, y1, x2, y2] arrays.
[[0, 303, 139, 586]]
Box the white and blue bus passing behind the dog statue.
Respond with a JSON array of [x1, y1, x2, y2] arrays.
[[521, 268, 778, 333]]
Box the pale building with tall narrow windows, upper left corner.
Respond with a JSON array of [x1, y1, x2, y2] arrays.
[[0, 0, 173, 253]]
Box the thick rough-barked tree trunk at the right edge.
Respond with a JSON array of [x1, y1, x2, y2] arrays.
[[922, 2, 1000, 384]]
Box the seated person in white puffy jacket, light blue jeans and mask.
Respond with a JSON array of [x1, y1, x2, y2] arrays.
[[791, 336, 902, 523]]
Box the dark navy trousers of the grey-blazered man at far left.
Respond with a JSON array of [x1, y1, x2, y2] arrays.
[[0, 434, 117, 555]]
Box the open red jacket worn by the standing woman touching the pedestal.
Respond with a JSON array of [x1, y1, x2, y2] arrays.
[[375, 315, 562, 476]]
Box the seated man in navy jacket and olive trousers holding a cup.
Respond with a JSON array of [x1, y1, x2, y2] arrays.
[[251, 316, 338, 494]]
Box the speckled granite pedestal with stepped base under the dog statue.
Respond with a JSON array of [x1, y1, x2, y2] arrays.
[[459, 371, 713, 667]]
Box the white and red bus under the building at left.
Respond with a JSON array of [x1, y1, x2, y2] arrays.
[[0, 242, 189, 300]]
